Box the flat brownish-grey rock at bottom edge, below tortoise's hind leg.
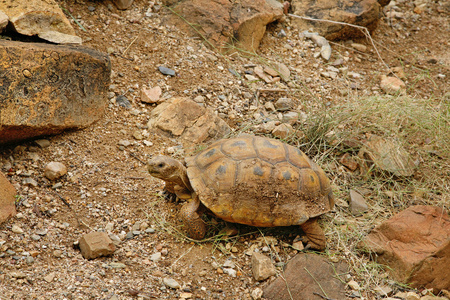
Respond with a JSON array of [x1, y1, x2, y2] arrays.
[[263, 253, 347, 300]]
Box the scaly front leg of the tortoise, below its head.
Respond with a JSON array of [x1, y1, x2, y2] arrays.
[[180, 197, 206, 240]]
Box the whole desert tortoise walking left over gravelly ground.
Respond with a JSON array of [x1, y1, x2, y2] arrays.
[[148, 135, 334, 250]]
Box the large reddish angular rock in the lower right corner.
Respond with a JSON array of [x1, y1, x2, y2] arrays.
[[359, 205, 450, 291]]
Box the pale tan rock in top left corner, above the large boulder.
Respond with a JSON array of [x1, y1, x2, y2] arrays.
[[0, 0, 75, 42]]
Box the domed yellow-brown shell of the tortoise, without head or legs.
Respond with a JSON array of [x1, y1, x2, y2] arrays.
[[185, 135, 334, 227]]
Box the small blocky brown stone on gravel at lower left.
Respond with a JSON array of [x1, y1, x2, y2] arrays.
[[79, 231, 116, 259]]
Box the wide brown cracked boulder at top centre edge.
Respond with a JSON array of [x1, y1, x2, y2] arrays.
[[166, 0, 283, 51]]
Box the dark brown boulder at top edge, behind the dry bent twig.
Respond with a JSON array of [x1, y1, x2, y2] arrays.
[[291, 0, 389, 40]]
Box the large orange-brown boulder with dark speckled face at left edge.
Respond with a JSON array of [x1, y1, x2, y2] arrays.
[[0, 40, 111, 144]]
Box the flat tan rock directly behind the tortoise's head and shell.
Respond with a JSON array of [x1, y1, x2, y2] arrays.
[[148, 97, 230, 148]]
